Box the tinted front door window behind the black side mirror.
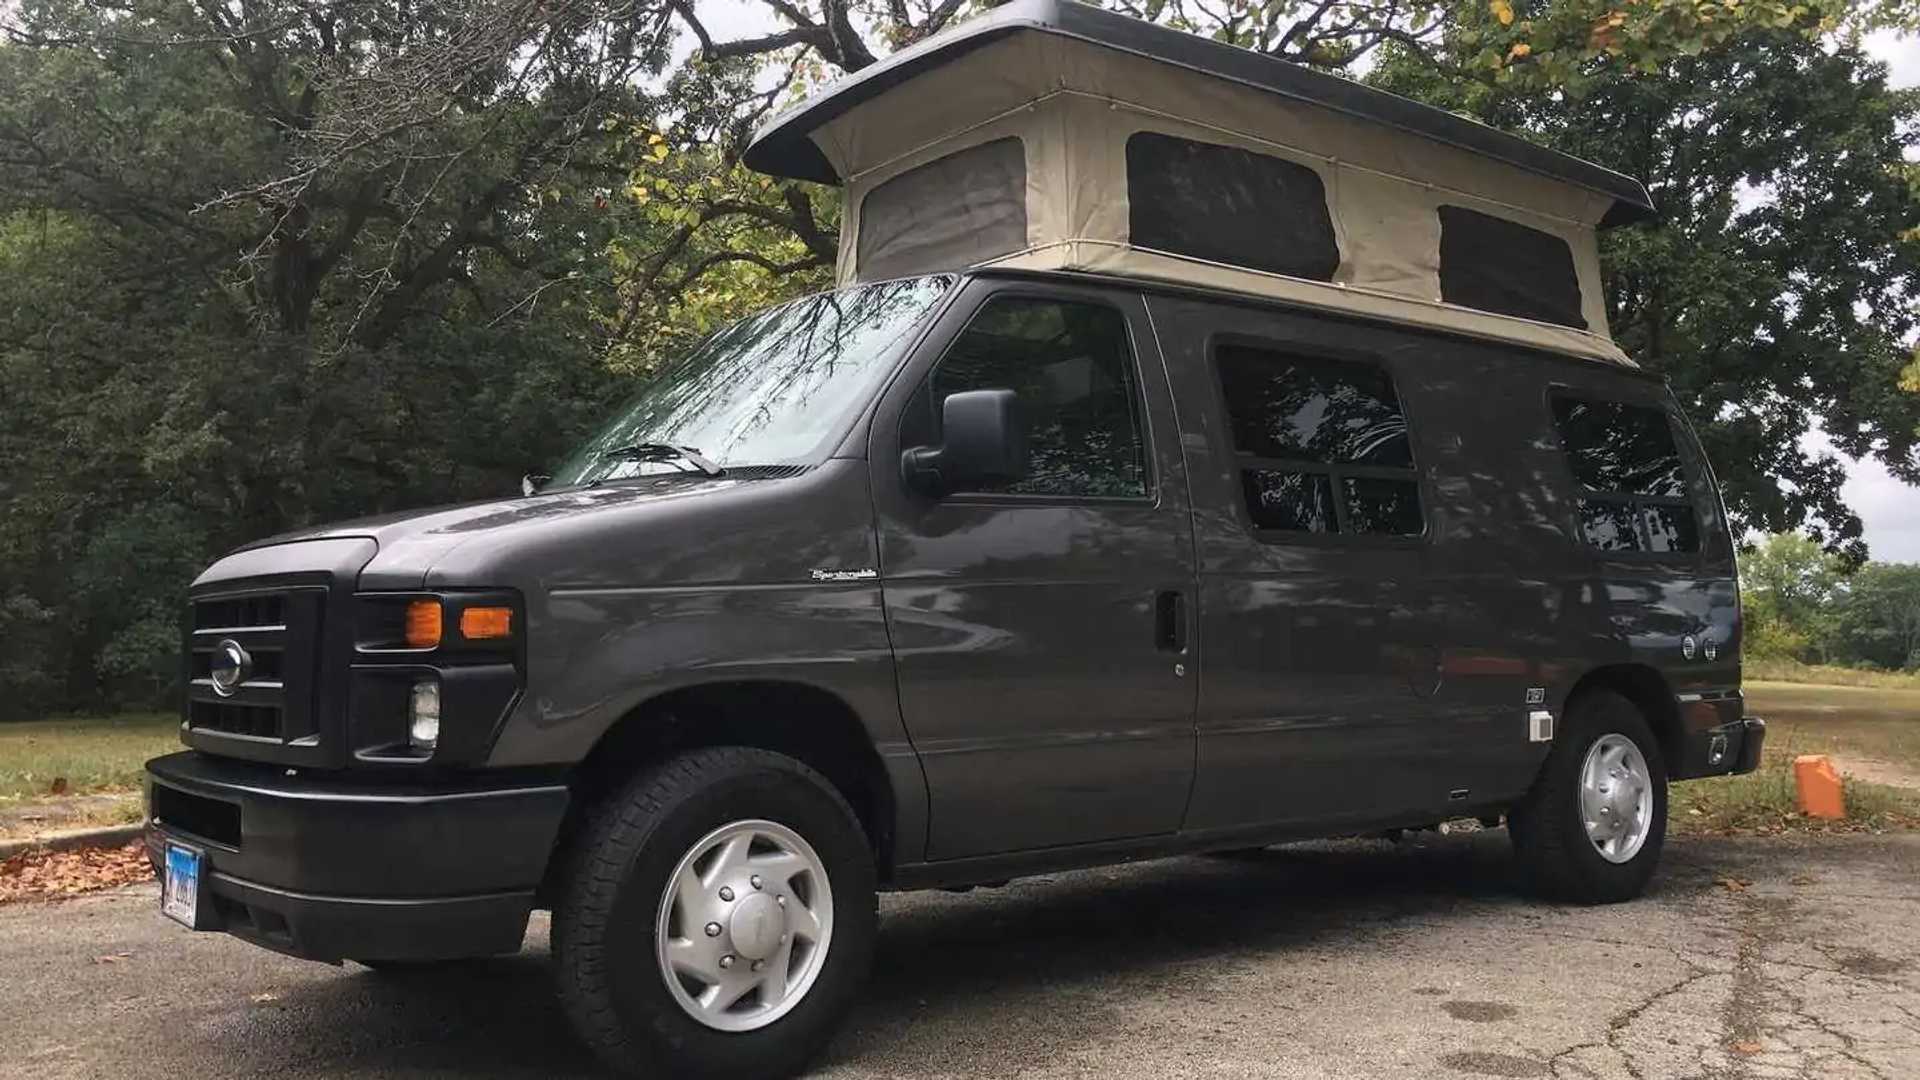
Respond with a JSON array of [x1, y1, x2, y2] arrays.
[[900, 298, 1148, 498]]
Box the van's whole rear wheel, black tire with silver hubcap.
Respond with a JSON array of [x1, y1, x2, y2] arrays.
[[1507, 690, 1667, 903]]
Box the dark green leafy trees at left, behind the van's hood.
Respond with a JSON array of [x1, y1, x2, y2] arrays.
[[0, 0, 657, 715]]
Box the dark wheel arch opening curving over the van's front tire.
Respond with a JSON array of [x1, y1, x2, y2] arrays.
[[540, 678, 895, 899]]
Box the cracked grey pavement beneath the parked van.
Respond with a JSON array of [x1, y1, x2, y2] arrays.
[[0, 832, 1920, 1080]]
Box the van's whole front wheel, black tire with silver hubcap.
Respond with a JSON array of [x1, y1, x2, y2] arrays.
[[553, 748, 876, 1078]]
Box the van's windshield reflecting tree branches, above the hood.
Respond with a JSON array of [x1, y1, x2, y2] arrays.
[[549, 275, 954, 486]]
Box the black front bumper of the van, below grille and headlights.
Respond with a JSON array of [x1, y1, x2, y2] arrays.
[[146, 751, 566, 961]]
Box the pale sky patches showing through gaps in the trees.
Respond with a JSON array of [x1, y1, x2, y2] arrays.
[[682, 8, 1920, 563]]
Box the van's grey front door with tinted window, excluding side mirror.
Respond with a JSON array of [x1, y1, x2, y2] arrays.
[[870, 279, 1196, 859]]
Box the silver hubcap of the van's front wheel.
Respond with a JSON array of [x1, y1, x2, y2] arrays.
[[655, 821, 833, 1032]]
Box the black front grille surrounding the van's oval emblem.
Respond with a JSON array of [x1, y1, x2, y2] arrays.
[[186, 586, 326, 746]]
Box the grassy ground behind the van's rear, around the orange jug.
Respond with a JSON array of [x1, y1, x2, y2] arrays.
[[1670, 680, 1920, 832]]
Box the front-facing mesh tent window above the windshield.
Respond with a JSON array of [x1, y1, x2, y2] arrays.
[[854, 138, 1027, 281]]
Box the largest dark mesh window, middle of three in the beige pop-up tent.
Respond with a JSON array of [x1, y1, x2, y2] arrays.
[[1127, 131, 1340, 281]]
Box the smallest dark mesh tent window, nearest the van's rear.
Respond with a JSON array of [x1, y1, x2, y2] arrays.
[[1440, 206, 1586, 331]]
